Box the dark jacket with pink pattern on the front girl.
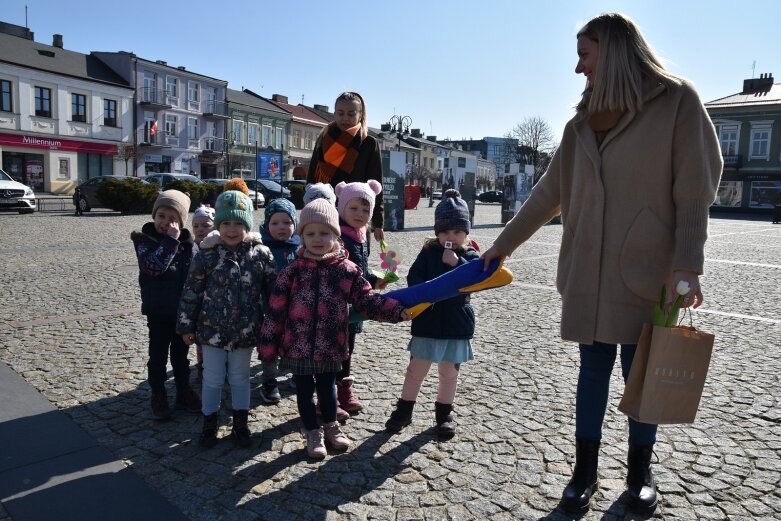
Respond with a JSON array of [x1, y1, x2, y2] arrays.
[[258, 248, 404, 361]]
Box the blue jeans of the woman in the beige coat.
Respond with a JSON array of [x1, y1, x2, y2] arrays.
[[575, 342, 657, 447]]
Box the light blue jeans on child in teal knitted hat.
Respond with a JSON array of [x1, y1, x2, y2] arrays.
[[201, 346, 252, 416]]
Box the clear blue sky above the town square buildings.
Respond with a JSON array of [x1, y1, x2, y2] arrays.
[[0, 0, 781, 139]]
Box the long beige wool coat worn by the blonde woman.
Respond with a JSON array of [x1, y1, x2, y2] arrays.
[[494, 82, 722, 344]]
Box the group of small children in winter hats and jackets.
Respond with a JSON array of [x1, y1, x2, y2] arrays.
[[131, 180, 478, 458]]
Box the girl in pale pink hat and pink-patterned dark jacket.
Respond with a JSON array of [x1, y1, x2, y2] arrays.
[[258, 199, 409, 459]]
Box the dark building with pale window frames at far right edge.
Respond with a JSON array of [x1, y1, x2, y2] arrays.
[[705, 74, 781, 211]]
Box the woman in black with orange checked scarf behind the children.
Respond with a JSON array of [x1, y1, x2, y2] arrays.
[[307, 92, 385, 241]]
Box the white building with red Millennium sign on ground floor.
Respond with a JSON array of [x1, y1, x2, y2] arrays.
[[0, 23, 133, 194]]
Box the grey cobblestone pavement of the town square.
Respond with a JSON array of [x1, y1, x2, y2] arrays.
[[0, 205, 781, 520]]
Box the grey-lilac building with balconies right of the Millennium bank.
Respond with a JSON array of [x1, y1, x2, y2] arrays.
[[92, 51, 228, 178]]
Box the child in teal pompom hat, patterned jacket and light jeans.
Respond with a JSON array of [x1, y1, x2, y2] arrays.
[[176, 190, 276, 448]]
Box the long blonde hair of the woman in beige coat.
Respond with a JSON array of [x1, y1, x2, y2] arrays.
[[577, 13, 681, 114]]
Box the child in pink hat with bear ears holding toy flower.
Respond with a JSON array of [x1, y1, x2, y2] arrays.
[[334, 179, 388, 421]]
